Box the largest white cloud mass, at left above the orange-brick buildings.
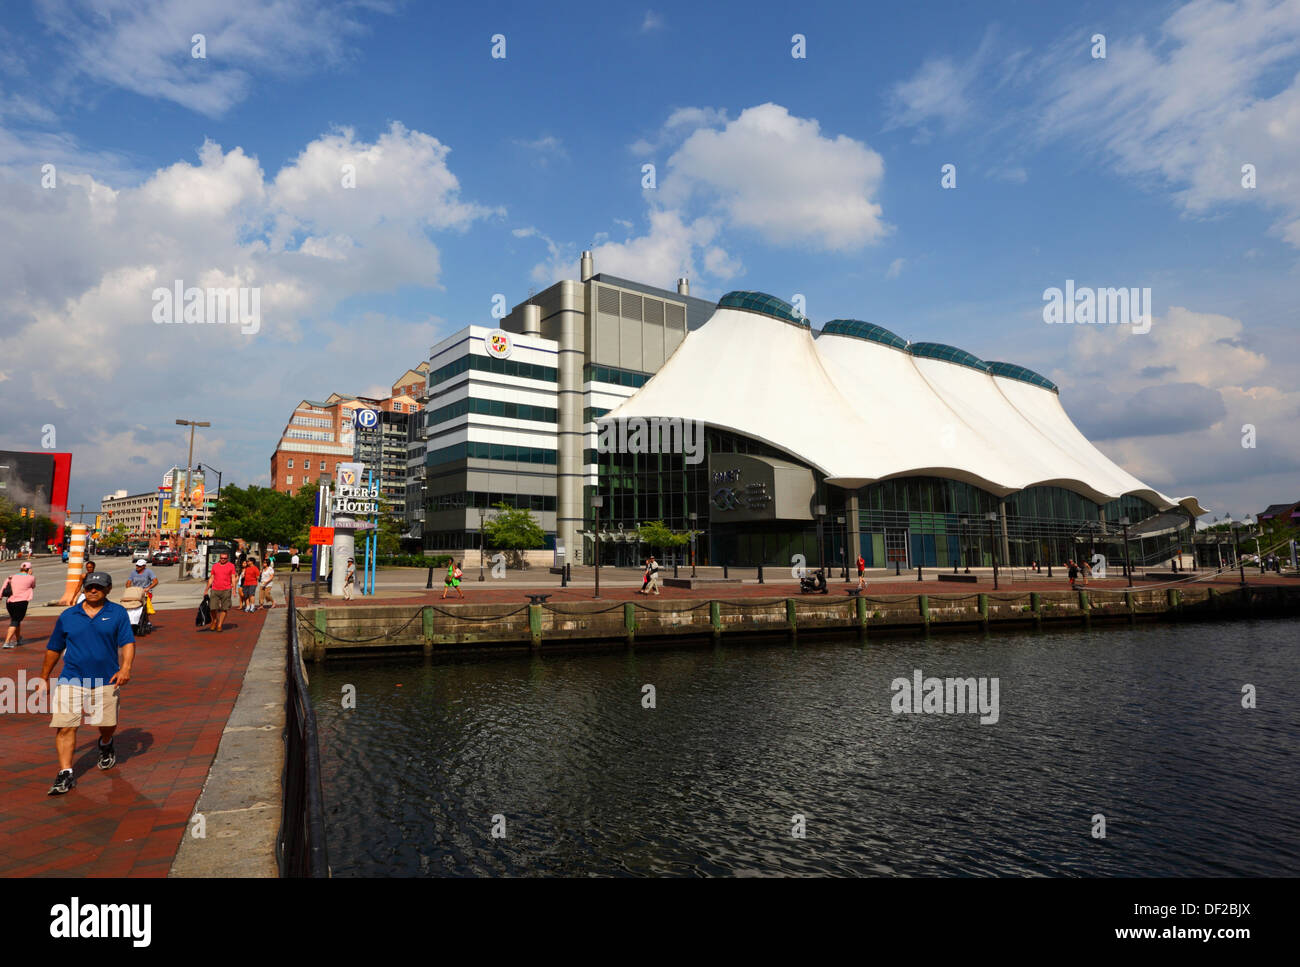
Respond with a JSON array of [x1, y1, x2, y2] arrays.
[[0, 125, 497, 493]]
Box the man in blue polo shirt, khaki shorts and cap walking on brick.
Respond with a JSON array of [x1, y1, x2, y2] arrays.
[[38, 571, 135, 795]]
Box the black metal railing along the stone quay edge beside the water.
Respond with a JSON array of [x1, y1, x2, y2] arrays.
[[276, 581, 329, 877]]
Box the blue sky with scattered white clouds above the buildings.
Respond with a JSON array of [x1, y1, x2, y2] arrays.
[[0, 0, 1300, 517]]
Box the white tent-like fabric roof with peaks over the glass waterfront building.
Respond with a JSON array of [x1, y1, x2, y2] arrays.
[[605, 294, 1205, 516]]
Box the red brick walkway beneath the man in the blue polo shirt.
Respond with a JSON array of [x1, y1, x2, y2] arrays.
[[0, 608, 263, 876]]
